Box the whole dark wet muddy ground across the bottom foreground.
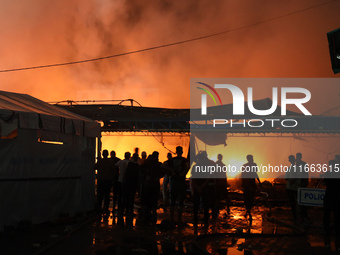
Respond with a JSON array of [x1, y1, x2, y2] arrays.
[[0, 201, 336, 255]]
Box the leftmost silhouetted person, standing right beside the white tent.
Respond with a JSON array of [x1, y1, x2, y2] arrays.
[[94, 150, 114, 214]]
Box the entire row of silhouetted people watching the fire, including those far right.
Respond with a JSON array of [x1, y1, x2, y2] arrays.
[[95, 146, 340, 247]]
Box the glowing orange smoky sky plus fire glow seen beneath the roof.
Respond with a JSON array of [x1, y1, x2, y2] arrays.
[[0, 0, 340, 174]]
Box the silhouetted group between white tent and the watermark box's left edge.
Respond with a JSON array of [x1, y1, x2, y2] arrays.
[[95, 146, 193, 226]]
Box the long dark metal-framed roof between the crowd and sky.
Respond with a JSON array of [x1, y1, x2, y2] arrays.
[[58, 98, 340, 134]]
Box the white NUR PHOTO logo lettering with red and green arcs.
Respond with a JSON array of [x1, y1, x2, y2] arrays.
[[195, 82, 312, 128]]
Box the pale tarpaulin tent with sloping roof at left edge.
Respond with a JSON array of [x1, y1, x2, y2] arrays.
[[0, 91, 100, 231]]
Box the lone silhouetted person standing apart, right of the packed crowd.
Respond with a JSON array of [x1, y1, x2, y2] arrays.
[[241, 155, 261, 222]]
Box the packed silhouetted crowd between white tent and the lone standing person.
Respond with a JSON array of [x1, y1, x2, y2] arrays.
[[95, 146, 236, 226]]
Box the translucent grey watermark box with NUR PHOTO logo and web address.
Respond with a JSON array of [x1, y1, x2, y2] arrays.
[[189, 78, 340, 179]]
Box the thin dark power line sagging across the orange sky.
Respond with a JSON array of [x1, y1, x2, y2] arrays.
[[0, 0, 336, 73]]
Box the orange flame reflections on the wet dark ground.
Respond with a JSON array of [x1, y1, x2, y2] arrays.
[[96, 186, 325, 254]]
